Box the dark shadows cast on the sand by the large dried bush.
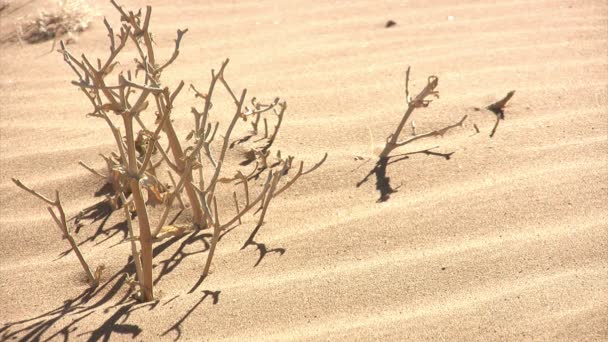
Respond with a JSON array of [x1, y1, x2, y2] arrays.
[[0, 179, 226, 341]]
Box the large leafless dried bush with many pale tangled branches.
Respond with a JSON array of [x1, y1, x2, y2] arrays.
[[14, 0, 327, 301]]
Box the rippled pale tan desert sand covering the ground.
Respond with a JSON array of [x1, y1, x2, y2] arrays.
[[0, 0, 608, 341]]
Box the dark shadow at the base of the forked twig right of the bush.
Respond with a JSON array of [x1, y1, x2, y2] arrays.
[[357, 147, 454, 203]]
